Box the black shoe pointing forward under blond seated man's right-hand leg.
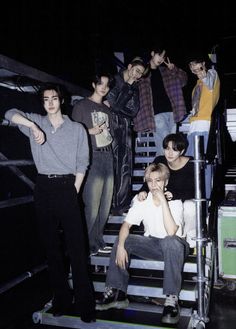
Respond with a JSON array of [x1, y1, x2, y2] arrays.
[[161, 295, 179, 324]]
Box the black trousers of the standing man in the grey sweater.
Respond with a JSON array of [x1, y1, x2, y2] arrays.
[[35, 175, 95, 315]]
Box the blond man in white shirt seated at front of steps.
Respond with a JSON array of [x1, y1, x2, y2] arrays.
[[96, 163, 189, 323]]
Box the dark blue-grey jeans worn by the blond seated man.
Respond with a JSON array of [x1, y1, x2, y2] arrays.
[[106, 234, 189, 296]]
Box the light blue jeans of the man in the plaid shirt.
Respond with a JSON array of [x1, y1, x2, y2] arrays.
[[153, 112, 176, 155]]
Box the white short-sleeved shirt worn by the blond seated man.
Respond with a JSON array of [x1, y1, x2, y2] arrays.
[[124, 192, 183, 238]]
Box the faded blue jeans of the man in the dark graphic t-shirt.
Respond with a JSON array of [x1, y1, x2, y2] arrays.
[[83, 151, 114, 252]]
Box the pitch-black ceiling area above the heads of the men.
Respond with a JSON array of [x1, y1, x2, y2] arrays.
[[0, 0, 236, 87]]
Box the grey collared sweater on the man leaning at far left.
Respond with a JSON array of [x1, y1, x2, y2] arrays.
[[5, 109, 89, 175]]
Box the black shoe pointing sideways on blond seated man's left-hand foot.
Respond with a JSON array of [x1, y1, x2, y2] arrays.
[[96, 287, 129, 311]]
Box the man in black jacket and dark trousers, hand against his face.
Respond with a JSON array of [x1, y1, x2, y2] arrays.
[[106, 57, 145, 215]]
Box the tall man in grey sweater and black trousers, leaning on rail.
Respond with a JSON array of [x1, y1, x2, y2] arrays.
[[5, 84, 95, 322]]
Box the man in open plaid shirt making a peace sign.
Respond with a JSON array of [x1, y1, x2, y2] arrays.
[[134, 48, 187, 155]]
